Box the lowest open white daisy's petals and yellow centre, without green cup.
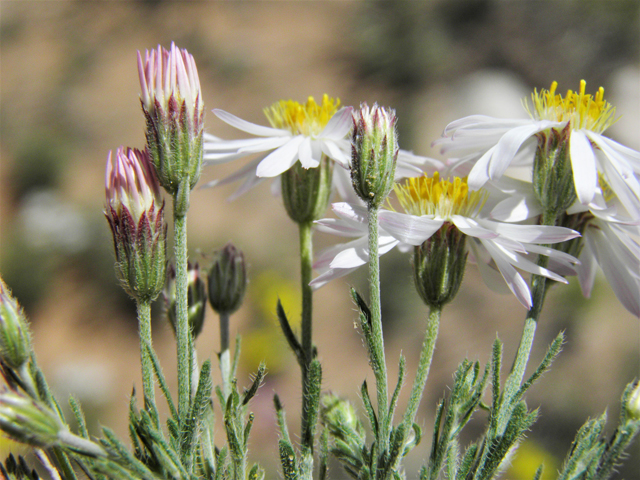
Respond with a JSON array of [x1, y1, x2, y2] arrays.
[[311, 173, 579, 308]]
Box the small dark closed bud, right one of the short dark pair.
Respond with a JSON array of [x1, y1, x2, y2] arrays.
[[209, 243, 247, 315]]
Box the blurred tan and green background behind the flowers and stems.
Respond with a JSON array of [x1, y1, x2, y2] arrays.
[[0, 0, 640, 479]]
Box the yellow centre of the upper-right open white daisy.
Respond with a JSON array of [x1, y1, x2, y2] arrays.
[[524, 80, 617, 133]]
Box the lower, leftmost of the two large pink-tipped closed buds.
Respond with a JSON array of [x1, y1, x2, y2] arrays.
[[105, 147, 167, 301]]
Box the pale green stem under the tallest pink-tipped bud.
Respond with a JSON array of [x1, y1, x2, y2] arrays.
[[174, 202, 192, 423]]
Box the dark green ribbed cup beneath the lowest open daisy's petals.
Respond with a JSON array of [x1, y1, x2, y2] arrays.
[[413, 222, 468, 308]]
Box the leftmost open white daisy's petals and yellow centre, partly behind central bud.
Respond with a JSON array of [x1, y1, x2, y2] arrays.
[[204, 94, 443, 199]]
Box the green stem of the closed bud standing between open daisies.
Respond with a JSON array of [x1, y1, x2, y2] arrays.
[[368, 203, 389, 455]]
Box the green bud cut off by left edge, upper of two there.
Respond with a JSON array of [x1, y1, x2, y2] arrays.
[[0, 278, 31, 370]]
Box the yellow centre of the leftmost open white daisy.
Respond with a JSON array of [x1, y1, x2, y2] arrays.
[[264, 93, 340, 137]]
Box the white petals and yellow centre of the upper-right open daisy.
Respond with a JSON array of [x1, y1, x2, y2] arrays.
[[434, 80, 640, 216]]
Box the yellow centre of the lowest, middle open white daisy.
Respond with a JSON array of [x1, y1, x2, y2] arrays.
[[394, 172, 488, 219]]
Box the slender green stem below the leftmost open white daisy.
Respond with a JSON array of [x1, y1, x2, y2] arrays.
[[298, 222, 314, 452]]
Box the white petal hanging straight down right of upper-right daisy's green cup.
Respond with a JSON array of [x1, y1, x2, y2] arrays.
[[569, 130, 598, 205]]
